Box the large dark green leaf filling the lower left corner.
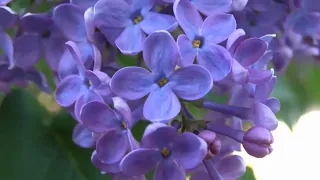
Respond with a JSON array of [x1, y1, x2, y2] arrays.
[[0, 90, 108, 180]]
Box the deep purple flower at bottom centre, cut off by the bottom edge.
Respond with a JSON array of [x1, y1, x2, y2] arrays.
[[120, 123, 207, 180]]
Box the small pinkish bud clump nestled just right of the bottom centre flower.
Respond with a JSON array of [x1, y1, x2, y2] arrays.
[[198, 130, 221, 158]]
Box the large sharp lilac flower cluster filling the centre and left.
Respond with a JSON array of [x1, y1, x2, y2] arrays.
[[0, 0, 284, 180]]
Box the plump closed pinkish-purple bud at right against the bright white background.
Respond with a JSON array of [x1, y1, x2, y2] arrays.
[[242, 126, 273, 158]]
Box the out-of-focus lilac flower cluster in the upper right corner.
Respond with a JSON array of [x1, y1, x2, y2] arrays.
[[233, 0, 320, 72]]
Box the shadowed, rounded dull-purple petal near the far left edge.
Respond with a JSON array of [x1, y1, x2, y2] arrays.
[[13, 35, 41, 69]]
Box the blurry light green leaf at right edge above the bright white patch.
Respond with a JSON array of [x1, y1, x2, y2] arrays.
[[273, 62, 320, 128]]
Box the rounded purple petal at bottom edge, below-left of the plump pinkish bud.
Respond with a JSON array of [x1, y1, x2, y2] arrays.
[[216, 155, 246, 179]]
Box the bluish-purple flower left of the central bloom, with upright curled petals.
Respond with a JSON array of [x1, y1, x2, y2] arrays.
[[55, 41, 111, 121]]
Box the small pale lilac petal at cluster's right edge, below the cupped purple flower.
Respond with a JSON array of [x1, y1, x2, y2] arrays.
[[249, 69, 273, 84]]
